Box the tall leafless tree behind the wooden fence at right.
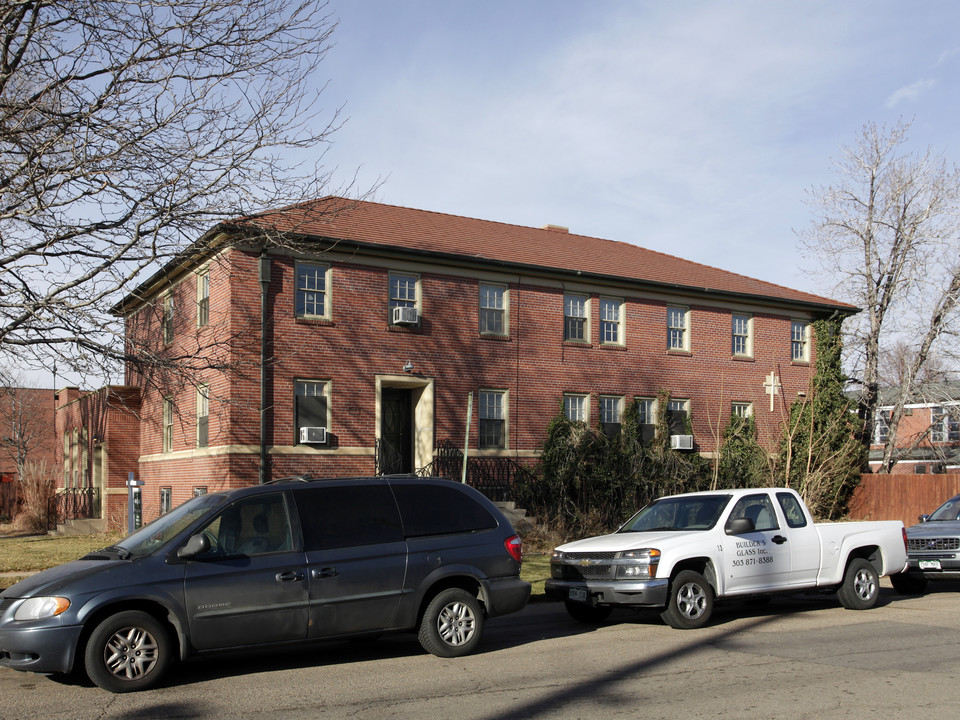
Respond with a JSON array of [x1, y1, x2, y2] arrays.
[[804, 122, 960, 472]]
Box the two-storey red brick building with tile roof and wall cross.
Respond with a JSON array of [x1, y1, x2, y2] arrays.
[[57, 198, 856, 522]]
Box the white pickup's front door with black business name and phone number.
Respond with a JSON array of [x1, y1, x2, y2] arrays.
[[723, 493, 791, 595]]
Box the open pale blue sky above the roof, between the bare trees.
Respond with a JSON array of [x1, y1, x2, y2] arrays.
[[321, 0, 960, 294]]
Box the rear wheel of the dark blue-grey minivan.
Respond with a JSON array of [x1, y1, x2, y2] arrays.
[[417, 588, 483, 657]]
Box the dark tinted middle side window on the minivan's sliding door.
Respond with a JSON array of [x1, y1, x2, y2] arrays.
[[293, 484, 403, 552]]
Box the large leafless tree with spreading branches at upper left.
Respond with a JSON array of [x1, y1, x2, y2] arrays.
[[0, 0, 339, 376]]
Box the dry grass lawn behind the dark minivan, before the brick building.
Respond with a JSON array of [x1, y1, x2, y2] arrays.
[[0, 527, 550, 600]]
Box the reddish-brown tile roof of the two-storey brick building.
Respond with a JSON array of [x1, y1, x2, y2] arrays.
[[236, 197, 856, 311]]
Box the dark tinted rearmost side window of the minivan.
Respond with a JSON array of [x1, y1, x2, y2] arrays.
[[393, 484, 497, 537]]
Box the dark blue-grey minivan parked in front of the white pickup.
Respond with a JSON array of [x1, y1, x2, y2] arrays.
[[0, 477, 530, 692]]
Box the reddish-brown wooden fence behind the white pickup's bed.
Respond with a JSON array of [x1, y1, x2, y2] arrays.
[[850, 474, 960, 527]]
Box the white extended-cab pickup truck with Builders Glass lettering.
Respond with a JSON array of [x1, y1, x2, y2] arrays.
[[546, 488, 907, 628]]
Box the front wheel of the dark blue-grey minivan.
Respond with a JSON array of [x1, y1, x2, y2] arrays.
[[84, 610, 171, 693]]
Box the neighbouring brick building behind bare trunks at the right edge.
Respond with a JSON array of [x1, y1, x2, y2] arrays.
[[870, 383, 960, 474]]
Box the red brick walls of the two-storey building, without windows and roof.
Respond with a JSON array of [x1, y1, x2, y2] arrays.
[[120, 246, 813, 517]]
